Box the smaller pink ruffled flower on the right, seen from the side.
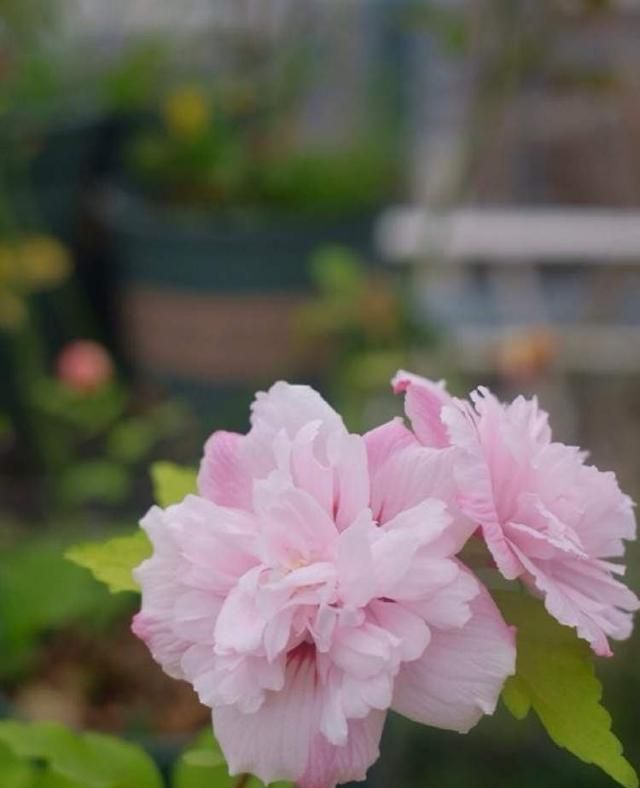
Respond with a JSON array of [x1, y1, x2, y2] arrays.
[[393, 372, 640, 656]]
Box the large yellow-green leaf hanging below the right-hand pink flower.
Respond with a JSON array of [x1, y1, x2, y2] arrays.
[[495, 592, 638, 788]]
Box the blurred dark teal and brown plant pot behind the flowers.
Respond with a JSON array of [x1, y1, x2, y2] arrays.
[[101, 188, 375, 428]]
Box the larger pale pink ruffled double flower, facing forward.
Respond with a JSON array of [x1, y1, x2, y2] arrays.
[[134, 383, 515, 788]]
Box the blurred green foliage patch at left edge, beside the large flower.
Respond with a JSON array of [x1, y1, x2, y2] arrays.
[[0, 537, 122, 680]]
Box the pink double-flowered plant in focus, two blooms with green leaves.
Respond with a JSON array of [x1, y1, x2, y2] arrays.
[[33, 371, 639, 788]]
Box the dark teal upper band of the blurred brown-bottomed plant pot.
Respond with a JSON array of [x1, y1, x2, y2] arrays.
[[103, 189, 376, 292]]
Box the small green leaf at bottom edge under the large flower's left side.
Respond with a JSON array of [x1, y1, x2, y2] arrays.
[[173, 729, 292, 788]]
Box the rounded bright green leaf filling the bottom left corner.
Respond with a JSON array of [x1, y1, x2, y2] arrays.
[[0, 721, 162, 788]]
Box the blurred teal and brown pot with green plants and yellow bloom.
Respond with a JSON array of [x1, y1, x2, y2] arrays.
[[102, 83, 397, 426]]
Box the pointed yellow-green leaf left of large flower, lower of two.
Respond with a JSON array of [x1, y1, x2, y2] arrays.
[[65, 530, 151, 593]]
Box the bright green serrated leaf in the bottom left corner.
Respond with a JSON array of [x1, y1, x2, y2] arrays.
[[0, 720, 162, 788]]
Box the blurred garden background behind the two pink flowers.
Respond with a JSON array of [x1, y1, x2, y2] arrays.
[[0, 0, 640, 788]]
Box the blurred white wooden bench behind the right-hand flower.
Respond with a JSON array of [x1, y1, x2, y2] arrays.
[[378, 206, 640, 373]]
